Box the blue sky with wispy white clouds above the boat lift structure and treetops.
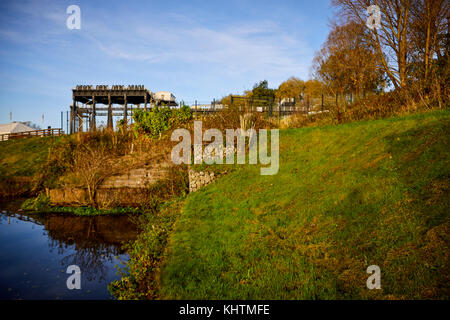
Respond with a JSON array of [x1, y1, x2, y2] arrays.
[[0, 0, 333, 127]]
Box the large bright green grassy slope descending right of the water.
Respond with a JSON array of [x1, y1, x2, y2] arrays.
[[160, 111, 450, 299]]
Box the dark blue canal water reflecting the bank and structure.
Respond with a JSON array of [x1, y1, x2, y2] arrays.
[[0, 200, 138, 300]]
